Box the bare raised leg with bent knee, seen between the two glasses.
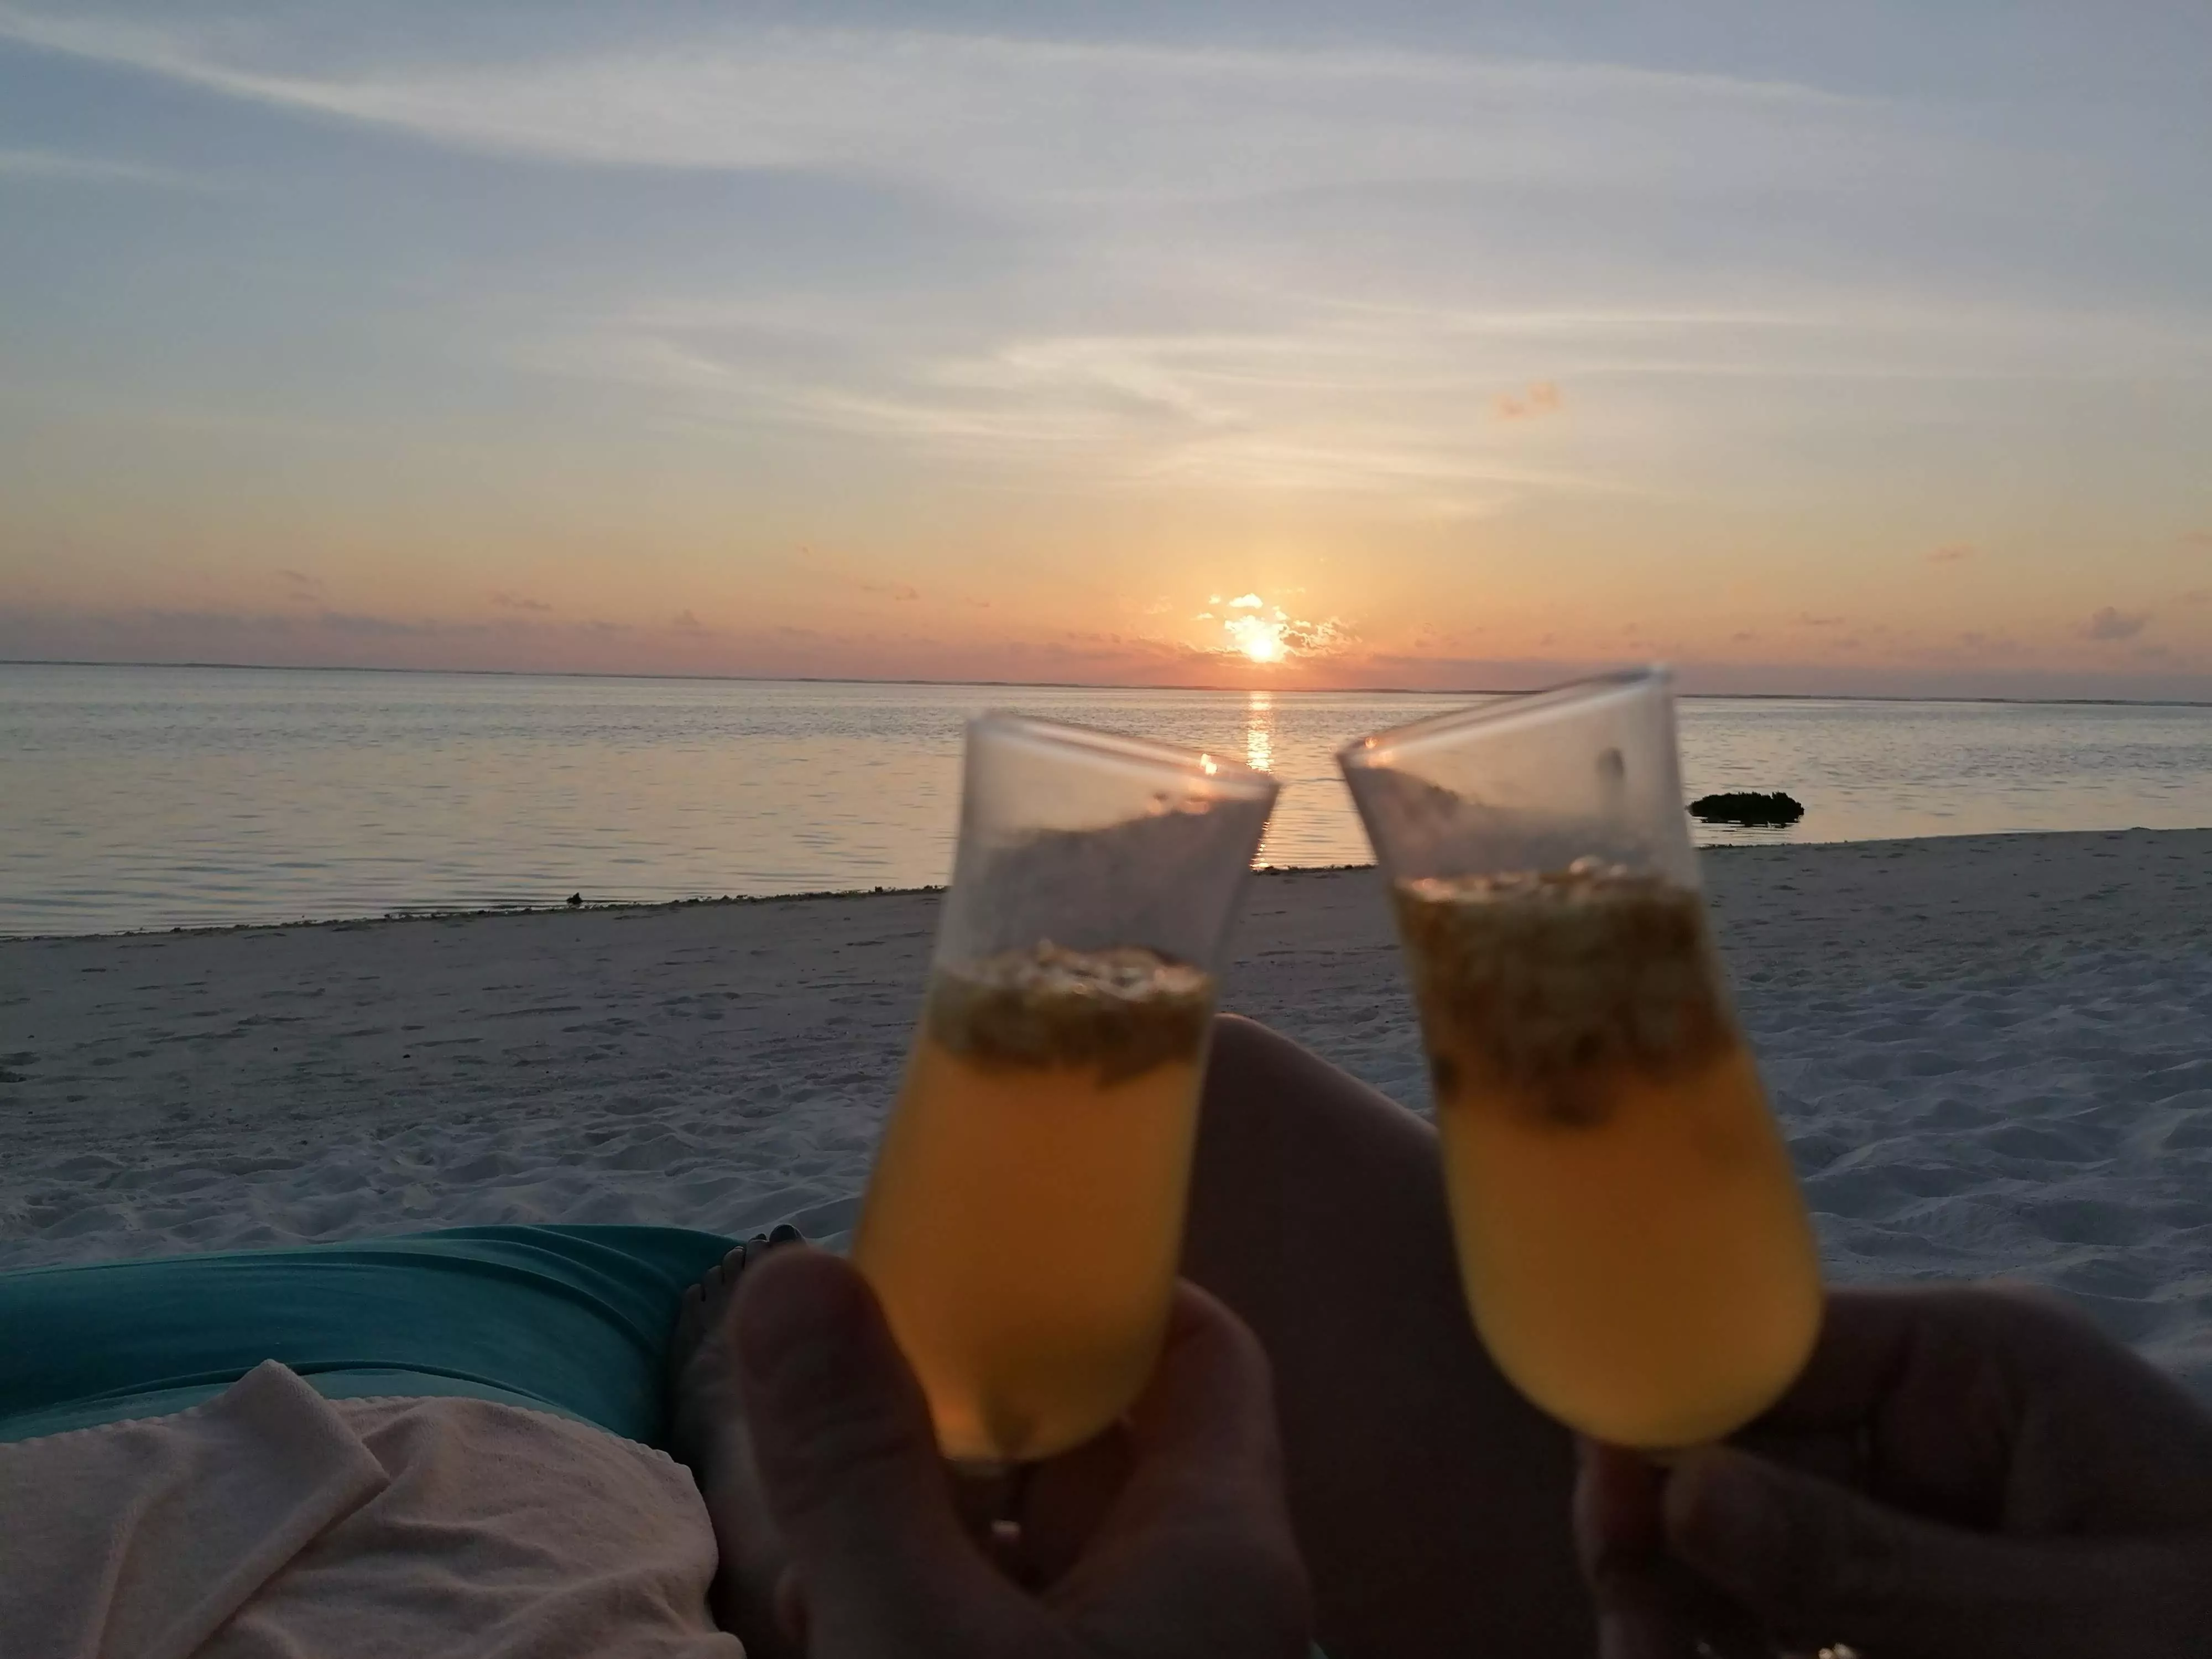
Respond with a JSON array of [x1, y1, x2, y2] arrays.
[[1183, 1015, 1595, 1659]]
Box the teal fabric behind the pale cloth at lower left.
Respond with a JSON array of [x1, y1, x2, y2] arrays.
[[0, 1228, 734, 1444]]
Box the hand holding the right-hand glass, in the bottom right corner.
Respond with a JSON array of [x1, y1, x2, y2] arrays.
[[1575, 1285, 2212, 1659]]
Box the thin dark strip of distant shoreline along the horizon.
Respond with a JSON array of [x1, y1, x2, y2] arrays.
[[0, 657, 2212, 708]]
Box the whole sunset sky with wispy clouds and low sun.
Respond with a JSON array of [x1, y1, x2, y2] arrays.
[[0, 0, 2212, 699]]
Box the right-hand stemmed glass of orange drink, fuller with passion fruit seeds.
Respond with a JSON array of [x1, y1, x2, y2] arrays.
[[1338, 670, 1820, 1449]]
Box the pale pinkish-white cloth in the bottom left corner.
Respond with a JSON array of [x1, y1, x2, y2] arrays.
[[0, 1360, 743, 1659]]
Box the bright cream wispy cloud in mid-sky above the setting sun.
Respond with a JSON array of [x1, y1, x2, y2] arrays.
[[553, 305, 1632, 513]]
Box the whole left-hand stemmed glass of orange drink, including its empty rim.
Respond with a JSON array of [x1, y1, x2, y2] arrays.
[[854, 714, 1276, 1469]]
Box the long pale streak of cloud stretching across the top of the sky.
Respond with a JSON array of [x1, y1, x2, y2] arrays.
[[0, 7, 1878, 201]]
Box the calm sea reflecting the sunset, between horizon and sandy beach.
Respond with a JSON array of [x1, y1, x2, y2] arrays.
[[13, 664, 2212, 933]]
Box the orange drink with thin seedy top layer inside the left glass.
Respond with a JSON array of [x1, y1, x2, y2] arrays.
[[854, 945, 1214, 1464]]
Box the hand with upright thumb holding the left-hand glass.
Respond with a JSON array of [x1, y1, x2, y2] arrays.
[[734, 1250, 1310, 1659]]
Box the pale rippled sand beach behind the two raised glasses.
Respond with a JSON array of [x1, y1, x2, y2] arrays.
[[0, 830, 2212, 1396]]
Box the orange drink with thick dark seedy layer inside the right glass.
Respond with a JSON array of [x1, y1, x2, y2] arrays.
[[1394, 860, 1820, 1449]]
